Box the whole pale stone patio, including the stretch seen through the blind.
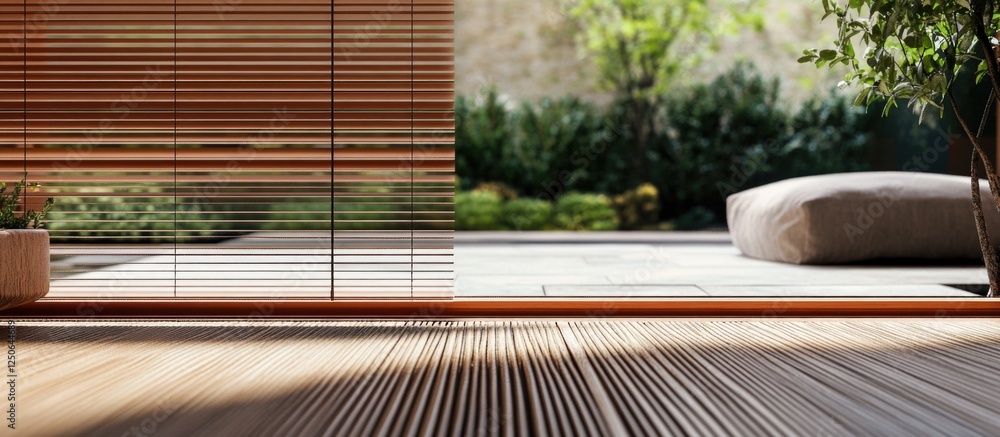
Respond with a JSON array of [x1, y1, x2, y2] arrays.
[[49, 232, 988, 299]]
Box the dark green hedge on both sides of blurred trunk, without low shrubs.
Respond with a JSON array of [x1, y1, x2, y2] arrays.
[[456, 63, 877, 229]]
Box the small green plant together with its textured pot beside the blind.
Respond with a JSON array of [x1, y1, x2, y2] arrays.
[[0, 181, 52, 310]]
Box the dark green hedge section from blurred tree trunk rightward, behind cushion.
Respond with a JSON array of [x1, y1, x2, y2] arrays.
[[651, 63, 871, 224]]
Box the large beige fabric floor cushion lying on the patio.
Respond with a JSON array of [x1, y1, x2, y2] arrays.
[[726, 172, 1000, 264]]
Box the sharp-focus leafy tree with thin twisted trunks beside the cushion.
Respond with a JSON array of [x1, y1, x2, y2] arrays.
[[799, 0, 1000, 297]]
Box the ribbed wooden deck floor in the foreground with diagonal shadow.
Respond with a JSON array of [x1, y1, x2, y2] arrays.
[[4, 319, 1000, 436]]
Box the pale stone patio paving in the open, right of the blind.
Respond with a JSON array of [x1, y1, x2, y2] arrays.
[[455, 232, 988, 297]]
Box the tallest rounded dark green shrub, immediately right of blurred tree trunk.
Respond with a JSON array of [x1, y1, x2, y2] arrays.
[[652, 63, 790, 217]]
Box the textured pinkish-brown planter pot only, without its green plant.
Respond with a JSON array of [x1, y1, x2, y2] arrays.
[[0, 229, 49, 310]]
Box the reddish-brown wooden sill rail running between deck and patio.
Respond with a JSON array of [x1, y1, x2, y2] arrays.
[[0, 298, 1000, 320]]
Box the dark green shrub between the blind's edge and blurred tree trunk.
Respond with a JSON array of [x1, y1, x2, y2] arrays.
[[455, 90, 608, 199]]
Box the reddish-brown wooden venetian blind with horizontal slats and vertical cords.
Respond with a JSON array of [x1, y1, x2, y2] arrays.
[[0, 0, 454, 299]]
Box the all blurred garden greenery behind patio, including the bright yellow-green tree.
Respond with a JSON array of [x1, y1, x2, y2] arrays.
[[456, 0, 995, 230]]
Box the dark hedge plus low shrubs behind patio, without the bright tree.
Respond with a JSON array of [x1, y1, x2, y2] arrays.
[[456, 62, 983, 230]]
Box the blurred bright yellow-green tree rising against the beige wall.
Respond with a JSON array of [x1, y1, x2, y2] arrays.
[[568, 0, 761, 184]]
